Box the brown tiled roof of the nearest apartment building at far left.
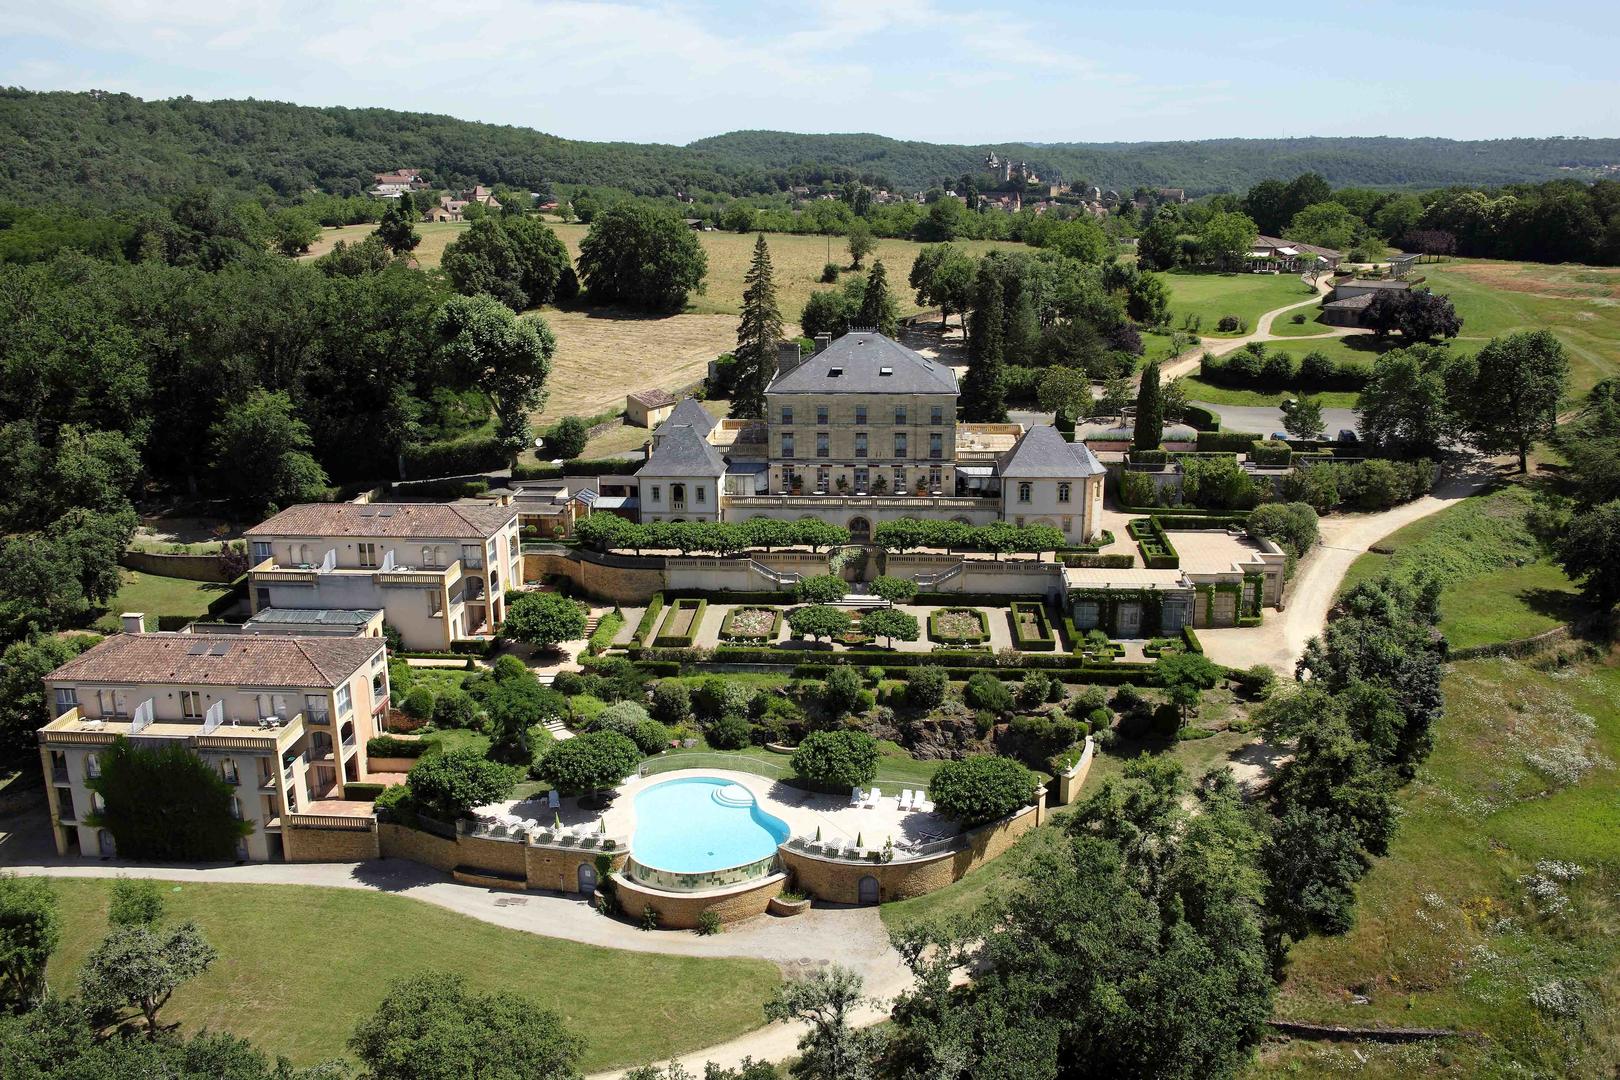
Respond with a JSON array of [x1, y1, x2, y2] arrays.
[[45, 633, 382, 688]]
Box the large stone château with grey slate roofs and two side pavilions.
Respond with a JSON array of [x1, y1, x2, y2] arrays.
[[637, 330, 1103, 544]]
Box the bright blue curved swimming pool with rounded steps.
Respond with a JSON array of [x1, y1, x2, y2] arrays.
[[630, 776, 791, 891]]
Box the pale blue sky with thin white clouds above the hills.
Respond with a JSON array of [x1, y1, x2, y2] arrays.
[[0, 0, 1620, 144]]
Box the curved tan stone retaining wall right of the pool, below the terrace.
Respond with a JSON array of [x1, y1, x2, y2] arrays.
[[781, 793, 1047, 904]]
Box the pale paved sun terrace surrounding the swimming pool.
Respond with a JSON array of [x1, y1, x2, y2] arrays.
[[480, 769, 957, 852]]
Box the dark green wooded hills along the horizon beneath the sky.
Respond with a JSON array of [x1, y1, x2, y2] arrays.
[[0, 87, 1620, 206]]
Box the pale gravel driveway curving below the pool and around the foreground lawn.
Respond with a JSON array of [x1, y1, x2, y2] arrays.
[[5, 845, 912, 1080]]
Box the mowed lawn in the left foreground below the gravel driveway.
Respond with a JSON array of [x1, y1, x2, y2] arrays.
[[49, 879, 781, 1072]]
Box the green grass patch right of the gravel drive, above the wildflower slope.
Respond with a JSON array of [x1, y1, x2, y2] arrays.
[[1341, 486, 1583, 648]]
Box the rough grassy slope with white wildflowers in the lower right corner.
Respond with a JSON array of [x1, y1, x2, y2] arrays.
[[1249, 656, 1620, 1078]]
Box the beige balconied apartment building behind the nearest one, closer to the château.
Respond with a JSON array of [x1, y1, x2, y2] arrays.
[[245, 502, 523, 649]]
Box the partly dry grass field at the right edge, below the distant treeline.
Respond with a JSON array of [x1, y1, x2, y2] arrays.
[[1418, 259, 1620, 400]]
